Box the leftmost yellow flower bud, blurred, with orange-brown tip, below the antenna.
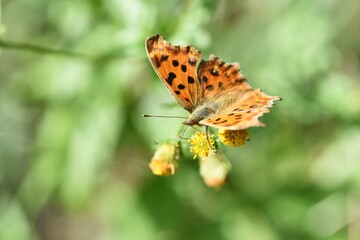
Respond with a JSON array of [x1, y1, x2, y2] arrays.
[[149, 143, 179, 176]]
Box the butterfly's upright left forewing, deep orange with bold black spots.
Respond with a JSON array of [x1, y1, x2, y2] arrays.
[[146, 34, 202, 112]]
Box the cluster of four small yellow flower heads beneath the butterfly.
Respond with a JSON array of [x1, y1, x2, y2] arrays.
[[149, 129, 249, 188]]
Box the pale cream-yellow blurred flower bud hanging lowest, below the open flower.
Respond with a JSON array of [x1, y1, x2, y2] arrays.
[[200, 152, 231, 188]]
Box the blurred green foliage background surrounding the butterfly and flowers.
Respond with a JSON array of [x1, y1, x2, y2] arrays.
[[0, 0, 360, 240]]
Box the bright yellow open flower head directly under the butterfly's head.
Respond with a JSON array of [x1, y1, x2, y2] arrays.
[[189, 132, 216, 158]]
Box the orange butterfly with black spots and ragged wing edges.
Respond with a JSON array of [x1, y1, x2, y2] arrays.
[[145, 34, 281, 130]]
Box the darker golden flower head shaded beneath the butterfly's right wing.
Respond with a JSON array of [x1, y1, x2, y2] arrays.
[[218, 129, 249, 147]]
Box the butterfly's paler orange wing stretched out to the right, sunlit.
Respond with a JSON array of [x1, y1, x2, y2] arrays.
[[199, 89, 281, 130]]
